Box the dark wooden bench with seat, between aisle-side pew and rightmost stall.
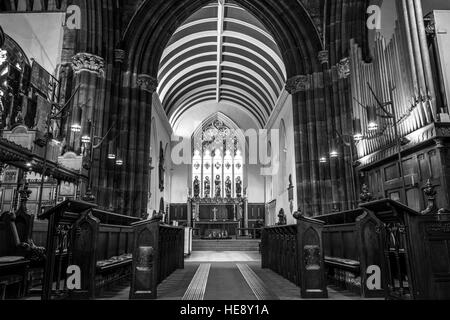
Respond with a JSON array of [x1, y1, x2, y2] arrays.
[[316, 209, 384, 298]]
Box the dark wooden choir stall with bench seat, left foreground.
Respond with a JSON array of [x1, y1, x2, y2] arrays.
[[39, 200, 140, 300]]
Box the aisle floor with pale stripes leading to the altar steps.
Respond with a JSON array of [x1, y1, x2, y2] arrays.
[[101, 251, 376, 300]]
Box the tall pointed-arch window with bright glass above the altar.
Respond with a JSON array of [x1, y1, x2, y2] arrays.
[[192, 120, 244, 198]]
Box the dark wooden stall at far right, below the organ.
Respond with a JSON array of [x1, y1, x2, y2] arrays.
[[361, 199, 450, 300]]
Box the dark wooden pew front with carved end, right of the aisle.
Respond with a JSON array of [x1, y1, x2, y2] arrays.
[[261, 217, 328, 298]]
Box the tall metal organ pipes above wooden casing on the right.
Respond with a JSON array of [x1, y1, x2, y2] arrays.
[[350, 0, 437, 158]]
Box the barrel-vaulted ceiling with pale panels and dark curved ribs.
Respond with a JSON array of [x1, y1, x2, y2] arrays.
[[158, 0, 286, 126]]
